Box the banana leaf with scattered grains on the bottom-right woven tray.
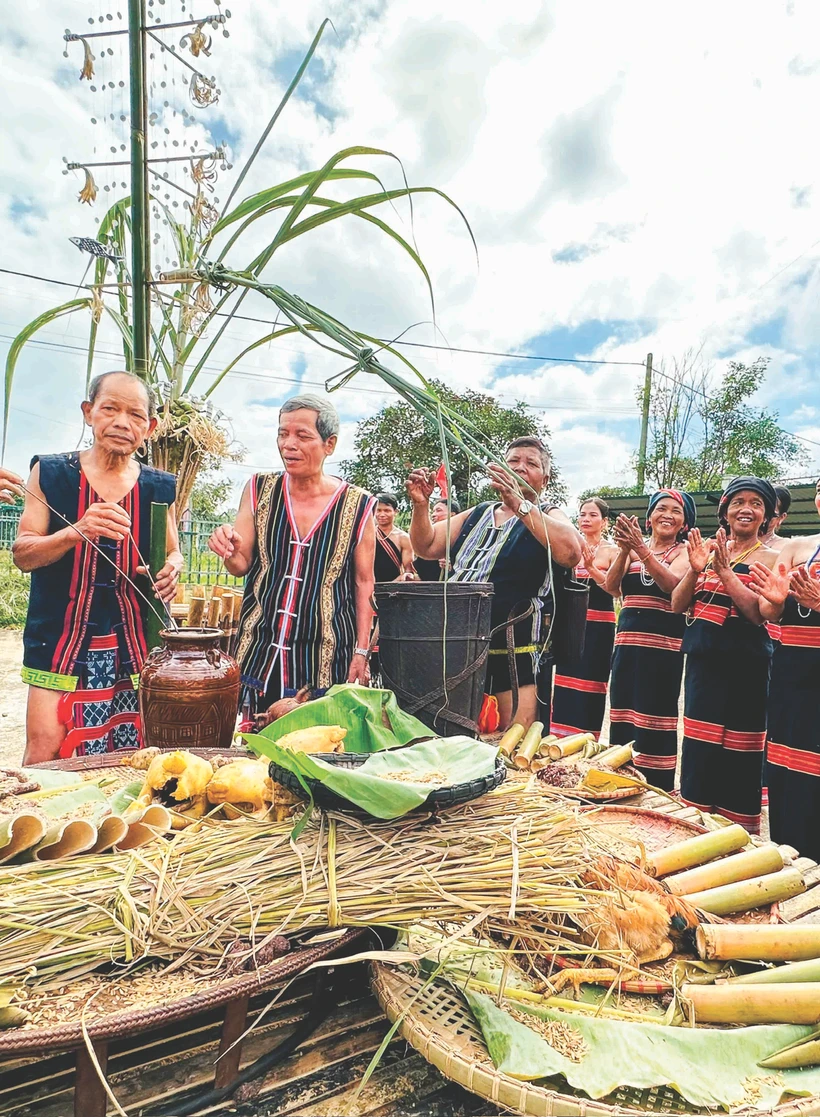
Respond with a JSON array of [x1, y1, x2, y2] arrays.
[[465, 991, 820, 1110]]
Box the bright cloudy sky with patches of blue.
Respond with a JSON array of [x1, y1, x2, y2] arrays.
[[0, 0, 820, 507]]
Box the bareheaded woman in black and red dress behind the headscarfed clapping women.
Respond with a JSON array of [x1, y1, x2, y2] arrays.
[[551, 496, 618, 739]]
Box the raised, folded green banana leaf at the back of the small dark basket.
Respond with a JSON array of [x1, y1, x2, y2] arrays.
[[250, 682, 432, 756]]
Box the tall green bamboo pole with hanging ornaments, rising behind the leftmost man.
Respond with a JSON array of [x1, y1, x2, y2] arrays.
[[128, 0, 151, 378]]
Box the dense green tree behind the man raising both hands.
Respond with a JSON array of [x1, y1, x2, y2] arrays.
[[341, 380, 566, 505]]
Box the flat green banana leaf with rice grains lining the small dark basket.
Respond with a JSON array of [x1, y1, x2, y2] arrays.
[[249, 737, 498, 819]]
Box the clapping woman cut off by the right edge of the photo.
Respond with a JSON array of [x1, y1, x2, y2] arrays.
[[752, 481, 820, 861]]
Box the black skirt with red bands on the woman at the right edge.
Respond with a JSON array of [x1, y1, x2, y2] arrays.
[[765, 601, 820, 861]]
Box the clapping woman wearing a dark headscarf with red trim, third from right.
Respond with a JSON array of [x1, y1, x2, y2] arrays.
[[604, 489, 696, 791]]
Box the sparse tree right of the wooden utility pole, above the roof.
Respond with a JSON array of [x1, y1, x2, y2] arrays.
[[639, 350, 803, 491]]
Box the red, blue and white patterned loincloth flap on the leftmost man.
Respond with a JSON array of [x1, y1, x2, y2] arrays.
[[58, 633, 142, 757]]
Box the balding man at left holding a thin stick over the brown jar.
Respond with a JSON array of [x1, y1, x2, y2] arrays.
[[13, 372, 182, 764]]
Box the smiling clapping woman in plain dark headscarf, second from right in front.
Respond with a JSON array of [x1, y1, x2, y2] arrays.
[[673, 477, 778, 833]]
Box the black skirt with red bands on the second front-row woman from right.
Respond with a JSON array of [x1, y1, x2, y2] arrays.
[[680, 650, 771, 833]]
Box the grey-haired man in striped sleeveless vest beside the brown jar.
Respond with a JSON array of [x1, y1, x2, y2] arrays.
[[209, 395, 375, 716]]
